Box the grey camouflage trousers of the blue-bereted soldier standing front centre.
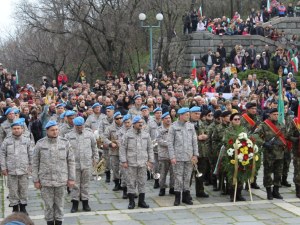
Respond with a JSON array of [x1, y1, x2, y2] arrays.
[[126, 166, 147, 194]]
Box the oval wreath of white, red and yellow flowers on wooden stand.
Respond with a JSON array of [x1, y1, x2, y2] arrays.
[[224, 132, 261, 183]]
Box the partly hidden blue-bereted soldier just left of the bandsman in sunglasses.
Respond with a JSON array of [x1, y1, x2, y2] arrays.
[[98, 105, 115, 183]]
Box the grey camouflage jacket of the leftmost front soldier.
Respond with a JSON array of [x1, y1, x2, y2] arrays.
[[1, 135, 33, 175]]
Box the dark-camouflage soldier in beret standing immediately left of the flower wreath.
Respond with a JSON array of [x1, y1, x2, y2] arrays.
[[209, 111, 231, 194]]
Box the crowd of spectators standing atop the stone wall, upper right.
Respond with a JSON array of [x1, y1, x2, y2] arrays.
[[183, 0, 300, 44]]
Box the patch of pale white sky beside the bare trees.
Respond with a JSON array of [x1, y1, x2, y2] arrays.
[[0, 0, 17, 38]]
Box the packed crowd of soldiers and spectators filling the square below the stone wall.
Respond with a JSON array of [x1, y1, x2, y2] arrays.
[[0, 36, 300, 225]]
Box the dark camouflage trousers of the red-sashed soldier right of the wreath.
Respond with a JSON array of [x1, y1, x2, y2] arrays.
[[263, 158, 283, 187]]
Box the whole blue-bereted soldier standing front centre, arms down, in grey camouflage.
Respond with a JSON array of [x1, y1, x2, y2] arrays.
[[120, 116, 154, 209]]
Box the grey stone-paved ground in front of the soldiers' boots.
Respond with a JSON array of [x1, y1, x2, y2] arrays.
[[0, 166, 300, 225]]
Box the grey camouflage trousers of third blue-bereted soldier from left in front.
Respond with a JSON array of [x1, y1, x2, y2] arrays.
[[71, 169, 91, 201]]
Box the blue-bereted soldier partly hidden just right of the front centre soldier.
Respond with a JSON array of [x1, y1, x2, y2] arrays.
[[149, 108, 162, 189]]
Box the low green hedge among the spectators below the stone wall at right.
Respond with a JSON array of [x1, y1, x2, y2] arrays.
[[238, 70, 300, 88]]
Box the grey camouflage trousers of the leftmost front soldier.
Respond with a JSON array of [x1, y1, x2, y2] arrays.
[[7, 174, 28, 207]]
